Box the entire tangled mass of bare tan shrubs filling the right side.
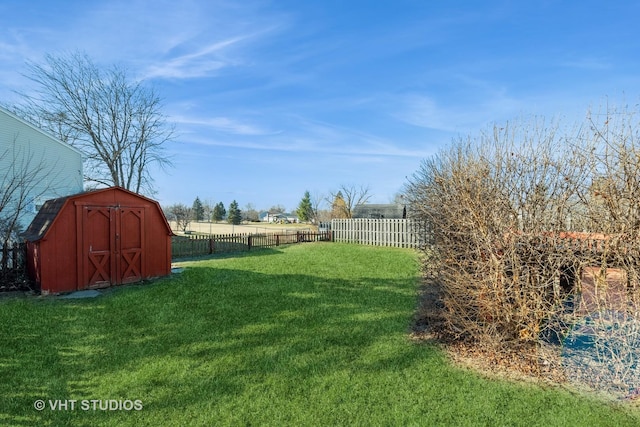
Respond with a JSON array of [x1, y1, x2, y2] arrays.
[[405, 108, 640, 392]]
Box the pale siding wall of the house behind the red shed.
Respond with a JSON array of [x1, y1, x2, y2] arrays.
[[0, 107, 83, 229]]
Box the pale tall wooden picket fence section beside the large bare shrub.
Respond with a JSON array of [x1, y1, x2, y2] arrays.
[[331, 218, 419, 248]]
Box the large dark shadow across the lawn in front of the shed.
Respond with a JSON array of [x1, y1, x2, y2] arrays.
[[0, 262, 424, 425]]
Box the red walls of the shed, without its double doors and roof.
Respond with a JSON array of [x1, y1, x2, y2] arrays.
[[28, 188, 171, 293]]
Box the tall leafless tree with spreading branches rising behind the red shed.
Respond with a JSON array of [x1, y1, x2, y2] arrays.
[[14, 53, 173, 193]]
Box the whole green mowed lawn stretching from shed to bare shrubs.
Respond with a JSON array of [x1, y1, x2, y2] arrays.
[[0, 243, 640, 426]]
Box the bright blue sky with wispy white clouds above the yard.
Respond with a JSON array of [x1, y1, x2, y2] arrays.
[[0, 0, 640, 210]]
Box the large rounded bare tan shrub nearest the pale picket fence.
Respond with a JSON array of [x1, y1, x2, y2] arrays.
[[406, 120, 584, 346]]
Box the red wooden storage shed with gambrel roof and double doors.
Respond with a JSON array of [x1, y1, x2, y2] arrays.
[[24, 187, 173, 294]]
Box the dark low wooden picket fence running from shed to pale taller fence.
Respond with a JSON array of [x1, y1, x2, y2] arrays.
[[171, 231, 331, 259]]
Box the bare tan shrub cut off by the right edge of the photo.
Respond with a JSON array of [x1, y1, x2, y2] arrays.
[[572, 107, 640, 391]]
